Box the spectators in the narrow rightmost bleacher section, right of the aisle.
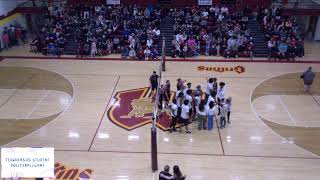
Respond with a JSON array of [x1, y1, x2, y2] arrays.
[[259, 7, 304, 60]]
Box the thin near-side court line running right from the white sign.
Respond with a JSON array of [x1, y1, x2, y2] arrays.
[[55, 149, 320, 160]]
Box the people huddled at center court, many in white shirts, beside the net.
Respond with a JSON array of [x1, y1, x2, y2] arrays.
[[149, 71, 231, 133]]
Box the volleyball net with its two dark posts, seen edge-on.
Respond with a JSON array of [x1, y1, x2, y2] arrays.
[[151, 37, 166, 171]]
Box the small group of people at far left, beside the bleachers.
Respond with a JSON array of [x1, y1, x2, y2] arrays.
[[0, 24, 27, 51]]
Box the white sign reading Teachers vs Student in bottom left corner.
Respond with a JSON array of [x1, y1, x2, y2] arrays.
[[1, 148, 54, 178]]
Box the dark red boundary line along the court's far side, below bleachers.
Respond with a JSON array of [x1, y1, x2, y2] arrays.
[[0, 56, 320, 64]]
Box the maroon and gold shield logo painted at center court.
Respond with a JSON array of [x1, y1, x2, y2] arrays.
[[108, 87, 175, 131]]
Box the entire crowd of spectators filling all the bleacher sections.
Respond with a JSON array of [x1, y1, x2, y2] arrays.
[[29, 5, 304, 59]]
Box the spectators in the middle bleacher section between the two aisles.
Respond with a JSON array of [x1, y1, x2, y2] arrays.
[[171, 6, 253, 57]]
